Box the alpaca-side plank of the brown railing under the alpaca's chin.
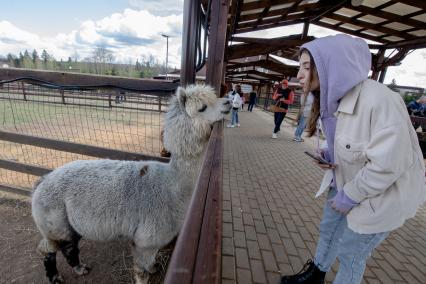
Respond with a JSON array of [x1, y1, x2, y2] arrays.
[[164, 122, 223, 284]]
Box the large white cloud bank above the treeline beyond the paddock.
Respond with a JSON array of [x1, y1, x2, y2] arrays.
[[0, 9, 182, 67]]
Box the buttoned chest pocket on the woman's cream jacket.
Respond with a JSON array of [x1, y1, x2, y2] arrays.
[[335, 137, 367, 164]]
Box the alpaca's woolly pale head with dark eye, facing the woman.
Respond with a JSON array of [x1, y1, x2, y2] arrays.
[[164, 85, 231, 157]]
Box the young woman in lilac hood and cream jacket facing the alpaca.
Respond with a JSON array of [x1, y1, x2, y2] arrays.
[[281, 35, 426, 284]]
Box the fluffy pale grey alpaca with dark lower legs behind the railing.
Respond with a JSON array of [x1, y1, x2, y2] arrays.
[[32, 85, 230, 283]]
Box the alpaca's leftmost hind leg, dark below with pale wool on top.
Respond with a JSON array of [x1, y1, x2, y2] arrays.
[[37, 239, 64, 284]]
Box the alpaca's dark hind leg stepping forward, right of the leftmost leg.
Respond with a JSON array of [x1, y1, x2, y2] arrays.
[[58, 235, 90, 276]]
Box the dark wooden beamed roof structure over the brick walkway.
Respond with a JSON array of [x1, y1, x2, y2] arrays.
[[220, 0, 426, 84]]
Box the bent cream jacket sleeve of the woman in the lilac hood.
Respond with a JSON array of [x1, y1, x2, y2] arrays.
[[343, 122, 413, 202]]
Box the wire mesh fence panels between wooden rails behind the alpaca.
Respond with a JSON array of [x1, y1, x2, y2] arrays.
[[0, 77, 170, 188]]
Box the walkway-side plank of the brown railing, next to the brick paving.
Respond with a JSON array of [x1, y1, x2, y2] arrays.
[[192, 123, 223, 284]]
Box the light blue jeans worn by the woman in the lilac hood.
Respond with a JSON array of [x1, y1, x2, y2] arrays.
[[314, 188, 389, 284]]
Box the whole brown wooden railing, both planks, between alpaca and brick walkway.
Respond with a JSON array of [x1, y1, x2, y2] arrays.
[[165, 122, 223, 284]]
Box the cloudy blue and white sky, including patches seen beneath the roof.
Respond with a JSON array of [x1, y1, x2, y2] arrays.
[[0, 0, 426, 88]]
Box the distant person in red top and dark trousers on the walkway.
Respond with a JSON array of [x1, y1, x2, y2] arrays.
[[272, 79, 294, 139]]
